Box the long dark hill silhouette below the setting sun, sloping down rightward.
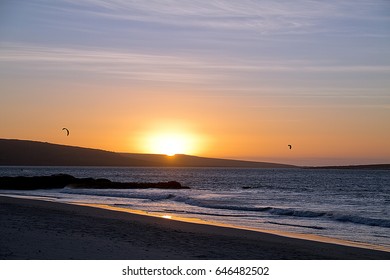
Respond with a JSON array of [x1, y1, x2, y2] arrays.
[[0, 139, 295, 168]]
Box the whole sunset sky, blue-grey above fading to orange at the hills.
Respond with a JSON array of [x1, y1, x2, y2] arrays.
[[0, 0, 390, 165]]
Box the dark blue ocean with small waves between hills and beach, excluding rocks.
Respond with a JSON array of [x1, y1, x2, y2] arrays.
[[0, 167, 390, 250]]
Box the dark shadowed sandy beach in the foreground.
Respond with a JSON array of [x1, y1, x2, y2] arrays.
[[0, 196, 390, 260]]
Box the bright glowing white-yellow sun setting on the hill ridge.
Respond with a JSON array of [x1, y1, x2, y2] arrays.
[[148, 133, 193, 156]]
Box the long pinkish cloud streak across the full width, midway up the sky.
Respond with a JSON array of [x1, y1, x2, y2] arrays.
[[0, 43, 390, 83]]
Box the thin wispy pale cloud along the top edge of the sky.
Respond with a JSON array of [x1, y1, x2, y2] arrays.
[[35, 0, 380, 32]]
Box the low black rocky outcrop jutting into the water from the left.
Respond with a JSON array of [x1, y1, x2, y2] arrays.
[[0, 174, 189, 190]]
